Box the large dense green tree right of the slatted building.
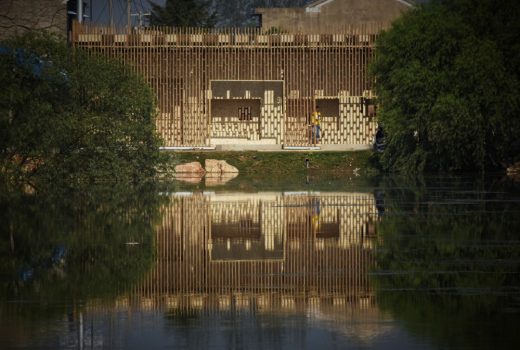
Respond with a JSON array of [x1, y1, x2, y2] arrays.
[[371, 0, 520, 172]]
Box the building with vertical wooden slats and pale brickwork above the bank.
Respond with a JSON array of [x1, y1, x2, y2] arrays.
[[72, 23, 382, 149]]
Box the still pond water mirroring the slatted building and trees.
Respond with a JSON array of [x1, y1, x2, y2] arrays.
[[0, 177, 520, 349]]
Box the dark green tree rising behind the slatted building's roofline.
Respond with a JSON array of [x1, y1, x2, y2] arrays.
[[150, 0, 215, 27]]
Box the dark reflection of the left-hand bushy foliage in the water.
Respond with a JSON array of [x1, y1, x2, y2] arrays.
[[0, 180, 159, 311]]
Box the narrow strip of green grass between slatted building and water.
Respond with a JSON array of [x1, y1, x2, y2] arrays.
[[158, 151, 376, 175]]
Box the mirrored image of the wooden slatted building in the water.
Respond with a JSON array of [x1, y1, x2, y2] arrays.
[[130, 193, 377, 309]]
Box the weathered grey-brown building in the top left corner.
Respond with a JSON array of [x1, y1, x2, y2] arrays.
[[0, 0, 68, 39]]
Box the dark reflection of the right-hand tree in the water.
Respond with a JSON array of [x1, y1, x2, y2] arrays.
[[376, 179, 520, 348]]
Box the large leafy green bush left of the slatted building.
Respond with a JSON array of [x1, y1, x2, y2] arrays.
[[0, 33, 159, 187]]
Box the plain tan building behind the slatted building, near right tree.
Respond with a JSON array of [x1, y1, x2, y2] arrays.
[[256, 0, 413, 34]]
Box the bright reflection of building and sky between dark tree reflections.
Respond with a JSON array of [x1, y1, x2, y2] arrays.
[[81, 192, 398, 349]]
